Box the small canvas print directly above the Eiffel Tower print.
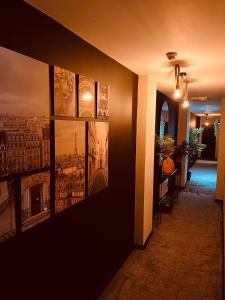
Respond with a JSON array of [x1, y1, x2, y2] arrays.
[[54, 66, 76, 117]]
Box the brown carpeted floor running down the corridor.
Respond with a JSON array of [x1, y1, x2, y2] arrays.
[[99, 162, 223, 300]]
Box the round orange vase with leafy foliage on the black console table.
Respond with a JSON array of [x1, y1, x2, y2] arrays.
[[155, 135, 176, 175]]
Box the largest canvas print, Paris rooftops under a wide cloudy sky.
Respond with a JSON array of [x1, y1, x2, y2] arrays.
[[0, 47, 50, 177]]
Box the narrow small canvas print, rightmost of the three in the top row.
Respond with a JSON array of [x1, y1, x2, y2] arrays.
[[97, 82, 109, 120]]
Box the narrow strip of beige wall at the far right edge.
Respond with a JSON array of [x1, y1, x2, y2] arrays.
[[216, 98, 225, 200]]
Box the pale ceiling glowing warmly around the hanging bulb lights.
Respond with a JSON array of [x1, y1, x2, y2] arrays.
[[27, 0, 225, 110]]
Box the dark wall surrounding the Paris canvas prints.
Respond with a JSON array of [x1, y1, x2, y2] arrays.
[[0, 1, 138, 299]]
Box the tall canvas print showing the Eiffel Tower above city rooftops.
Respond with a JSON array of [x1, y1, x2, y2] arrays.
[[55, 120, 85, 213]]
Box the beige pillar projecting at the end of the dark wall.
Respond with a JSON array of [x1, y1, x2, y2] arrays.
[[134, 75, 156, 246]]
